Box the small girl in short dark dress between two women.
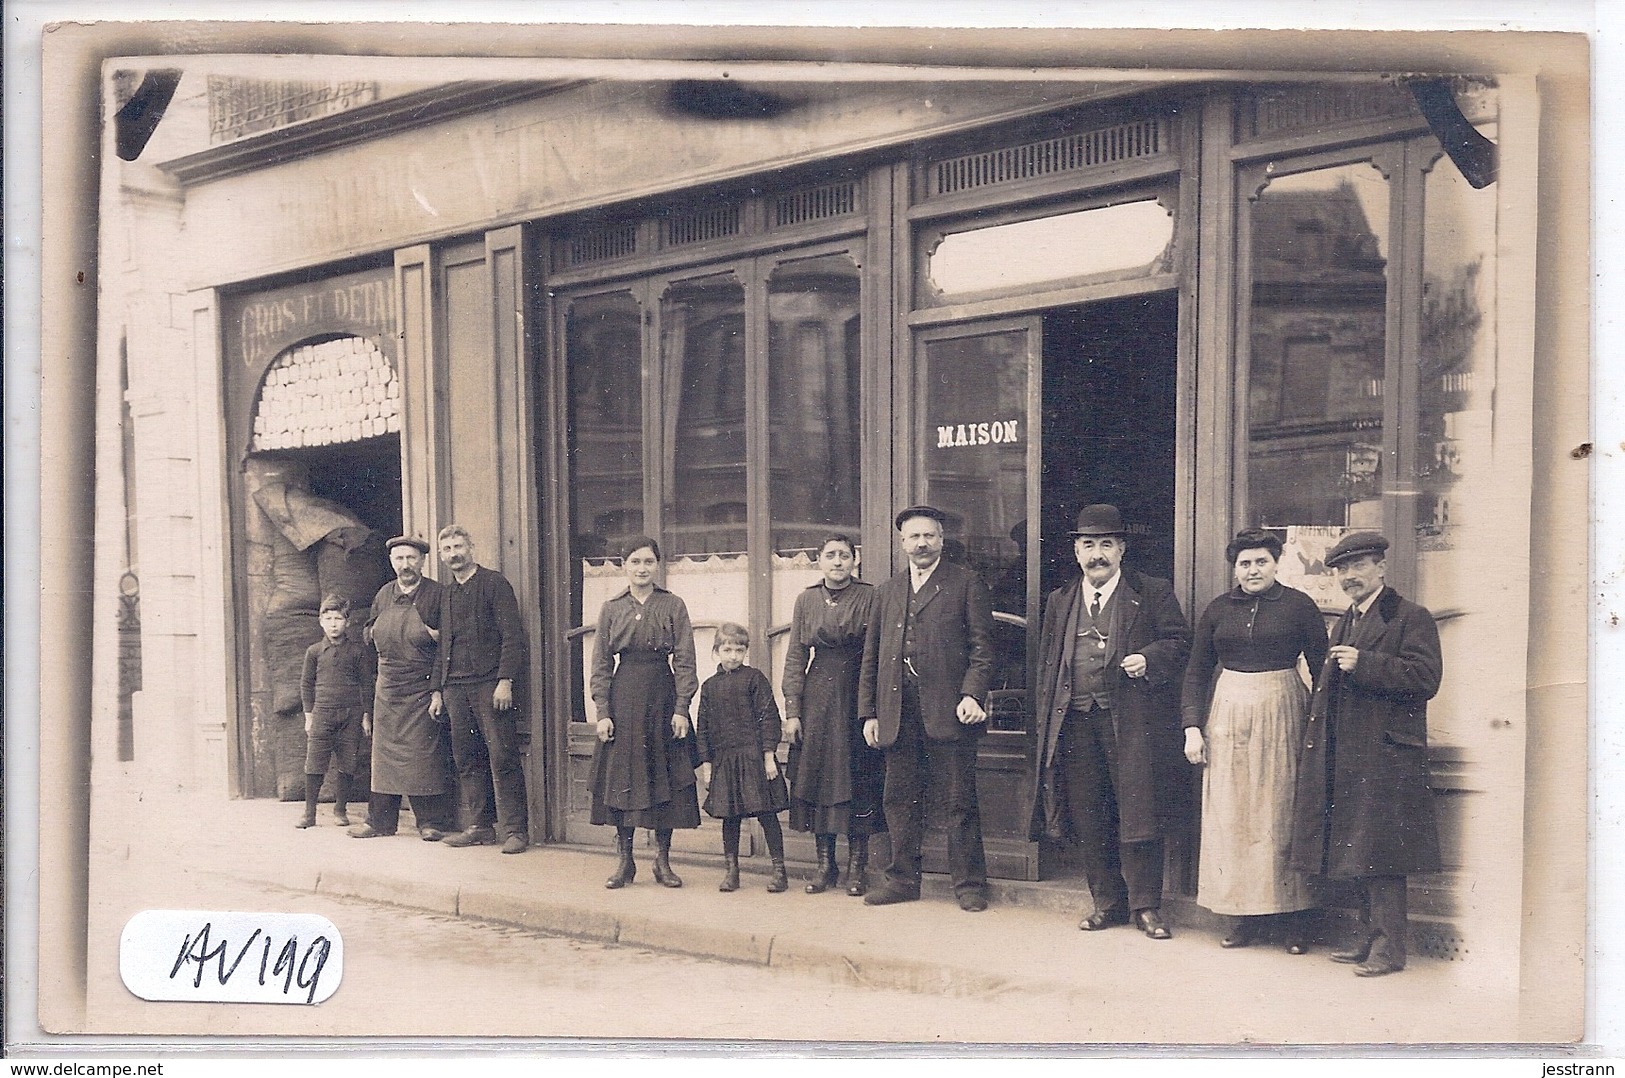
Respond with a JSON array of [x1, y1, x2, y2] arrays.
[[696, 621, 790, 894]]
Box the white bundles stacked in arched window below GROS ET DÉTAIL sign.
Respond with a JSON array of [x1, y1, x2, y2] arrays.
[[254, 337, 401, 450]]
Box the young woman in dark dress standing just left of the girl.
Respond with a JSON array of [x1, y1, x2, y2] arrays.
[[592, 535, 700, 888]]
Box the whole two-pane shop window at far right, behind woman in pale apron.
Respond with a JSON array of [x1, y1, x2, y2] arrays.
[[1238, 137, 1495, 608]]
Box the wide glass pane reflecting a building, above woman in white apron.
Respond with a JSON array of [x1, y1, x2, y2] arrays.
[[1246, 163, 1389, 528]]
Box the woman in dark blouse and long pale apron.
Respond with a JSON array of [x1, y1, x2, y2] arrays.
[[1181, 530, 1326, 954]]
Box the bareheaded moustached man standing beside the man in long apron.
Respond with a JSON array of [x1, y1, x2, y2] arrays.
[[429, 524, 530, 854]]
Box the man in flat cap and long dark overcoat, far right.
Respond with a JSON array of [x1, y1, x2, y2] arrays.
[[1292, 532, 1443, 977]]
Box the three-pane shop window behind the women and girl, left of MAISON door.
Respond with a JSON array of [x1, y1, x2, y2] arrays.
[[561, 247, 863, 741]]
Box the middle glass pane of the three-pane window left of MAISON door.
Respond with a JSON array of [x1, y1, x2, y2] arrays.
[[660, 275, 748, 556]]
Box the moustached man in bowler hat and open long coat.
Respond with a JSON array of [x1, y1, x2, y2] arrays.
[[1032, 506, 1191, 940]]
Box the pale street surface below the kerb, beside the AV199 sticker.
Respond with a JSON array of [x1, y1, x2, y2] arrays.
[[104, 878, 1105, 1042]]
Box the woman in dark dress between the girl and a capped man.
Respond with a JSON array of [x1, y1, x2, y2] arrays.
[[780, 535, 886, 896]]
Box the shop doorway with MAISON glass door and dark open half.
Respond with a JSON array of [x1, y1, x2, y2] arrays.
[[913, 291, 1180, 878]]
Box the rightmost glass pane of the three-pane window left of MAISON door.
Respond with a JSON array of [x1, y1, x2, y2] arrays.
[[767, 254, 861, 554]]
